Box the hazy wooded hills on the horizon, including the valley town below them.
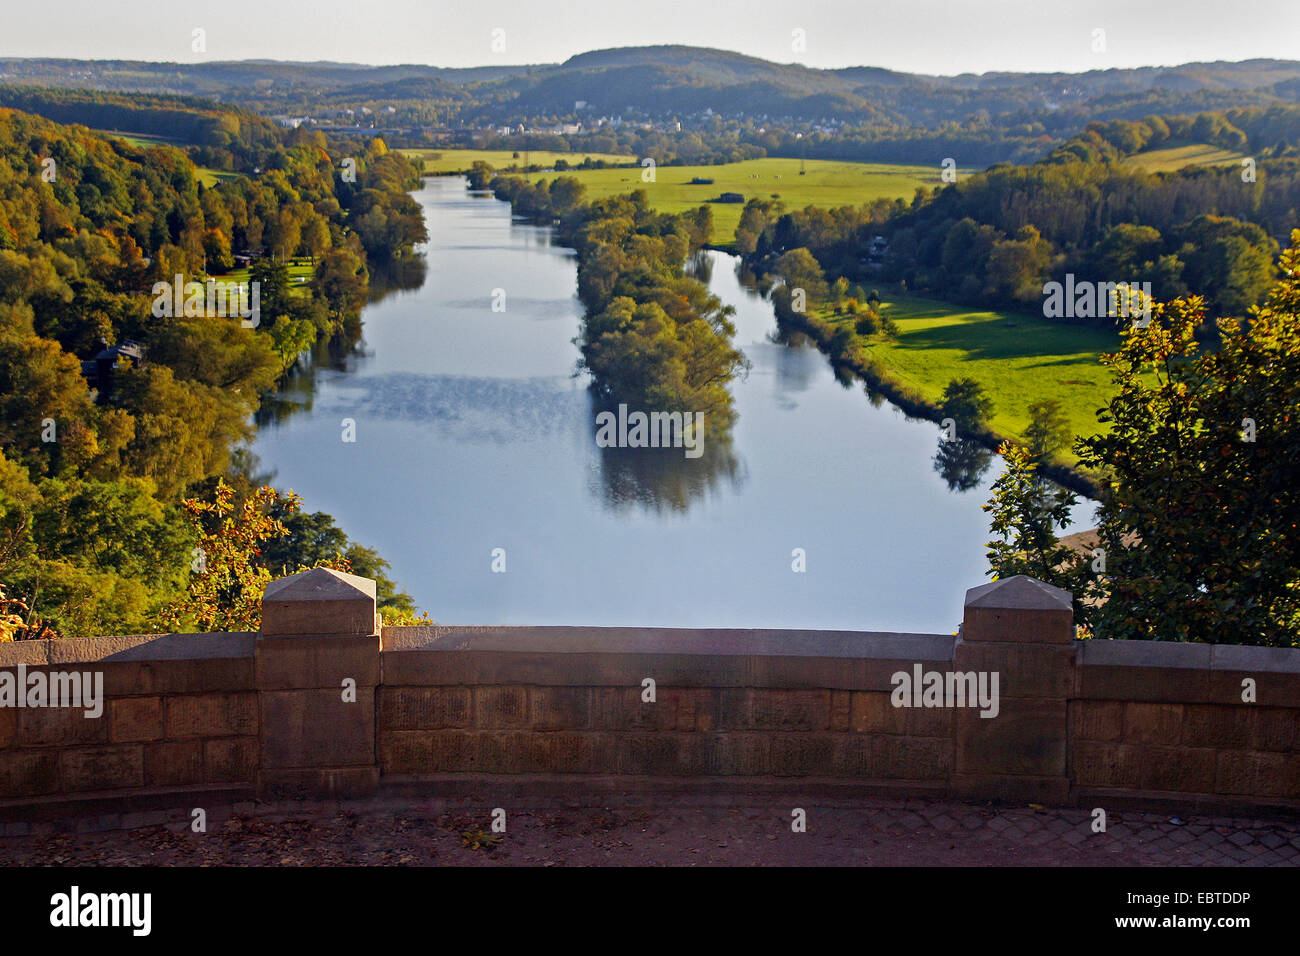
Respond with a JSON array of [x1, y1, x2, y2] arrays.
[[0, 46, 1300, 168]]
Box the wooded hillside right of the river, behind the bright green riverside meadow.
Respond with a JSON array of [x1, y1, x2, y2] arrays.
[[736, 107, 1300, 325]]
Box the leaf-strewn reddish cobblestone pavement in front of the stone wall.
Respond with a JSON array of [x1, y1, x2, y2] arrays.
[[0, 796, 1300, 866]]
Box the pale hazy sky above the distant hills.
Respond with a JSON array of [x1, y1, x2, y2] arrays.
[[0, 0, 1300, 74]]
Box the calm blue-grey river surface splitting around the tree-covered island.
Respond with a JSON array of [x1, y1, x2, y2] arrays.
[[254, 177, 1088, 632]]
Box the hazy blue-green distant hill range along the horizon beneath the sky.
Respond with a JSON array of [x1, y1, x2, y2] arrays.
[[0, 46, 1300, 143]]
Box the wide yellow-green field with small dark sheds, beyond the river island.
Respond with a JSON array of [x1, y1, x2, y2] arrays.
[[522, 159, 940, 245]]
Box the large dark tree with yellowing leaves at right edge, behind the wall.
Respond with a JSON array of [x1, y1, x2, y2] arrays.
[[1079, 230, 1300, 646]]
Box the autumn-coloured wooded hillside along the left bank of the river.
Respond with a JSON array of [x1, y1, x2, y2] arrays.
[[0, 104, 424, 637]]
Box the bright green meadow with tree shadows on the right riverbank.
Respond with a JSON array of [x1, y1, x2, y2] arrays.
[[819, 291, 1119, 463]]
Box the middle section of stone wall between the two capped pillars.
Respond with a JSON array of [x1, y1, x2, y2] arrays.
[[377, 627, 953, 788]]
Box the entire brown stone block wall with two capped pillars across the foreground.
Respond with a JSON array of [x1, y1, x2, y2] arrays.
[[0, 568, 1300, 819]]
